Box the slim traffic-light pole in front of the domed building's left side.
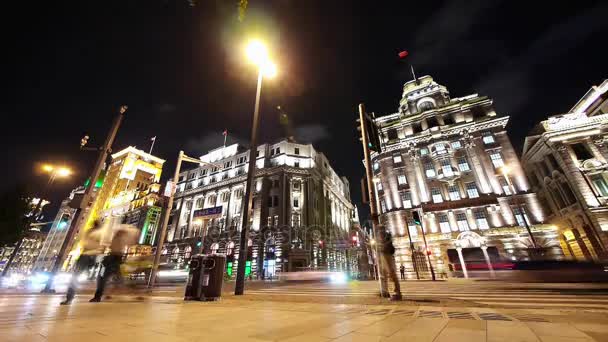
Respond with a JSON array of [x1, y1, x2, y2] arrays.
[[359, 103, 388, 296]]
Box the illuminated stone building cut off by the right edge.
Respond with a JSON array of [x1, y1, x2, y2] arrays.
[[522, 80, 608, 260]]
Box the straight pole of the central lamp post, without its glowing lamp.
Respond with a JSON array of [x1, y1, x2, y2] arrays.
[[234, 69, 262, 296]]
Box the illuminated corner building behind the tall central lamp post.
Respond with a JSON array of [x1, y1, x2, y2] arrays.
[[163, 140, 357, 277]]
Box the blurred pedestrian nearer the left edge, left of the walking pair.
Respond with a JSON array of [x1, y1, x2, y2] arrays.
[[60, 220, 103, 305]]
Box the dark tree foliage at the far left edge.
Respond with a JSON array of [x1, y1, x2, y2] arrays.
[[0, 185, 29, 246]]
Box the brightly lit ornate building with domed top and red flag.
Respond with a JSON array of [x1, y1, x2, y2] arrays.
[[372, 76, 563, 278]]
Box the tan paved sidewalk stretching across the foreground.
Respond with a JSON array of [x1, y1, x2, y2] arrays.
[[0, 296, 608, 342]]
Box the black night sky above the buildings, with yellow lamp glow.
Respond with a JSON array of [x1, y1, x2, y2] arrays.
[[0, 0, 608, 222]]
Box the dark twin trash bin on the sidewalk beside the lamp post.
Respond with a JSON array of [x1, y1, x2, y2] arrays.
[[184, 254, 226, 301]]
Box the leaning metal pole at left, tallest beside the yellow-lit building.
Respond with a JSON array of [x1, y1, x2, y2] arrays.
[[42, 106, 127, 293]]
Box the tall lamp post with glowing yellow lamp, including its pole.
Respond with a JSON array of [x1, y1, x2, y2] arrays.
[[234, 40, 277, 296]]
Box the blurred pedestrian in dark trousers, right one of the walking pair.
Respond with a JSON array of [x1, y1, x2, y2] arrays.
[[89, 224, 139, 303]]
